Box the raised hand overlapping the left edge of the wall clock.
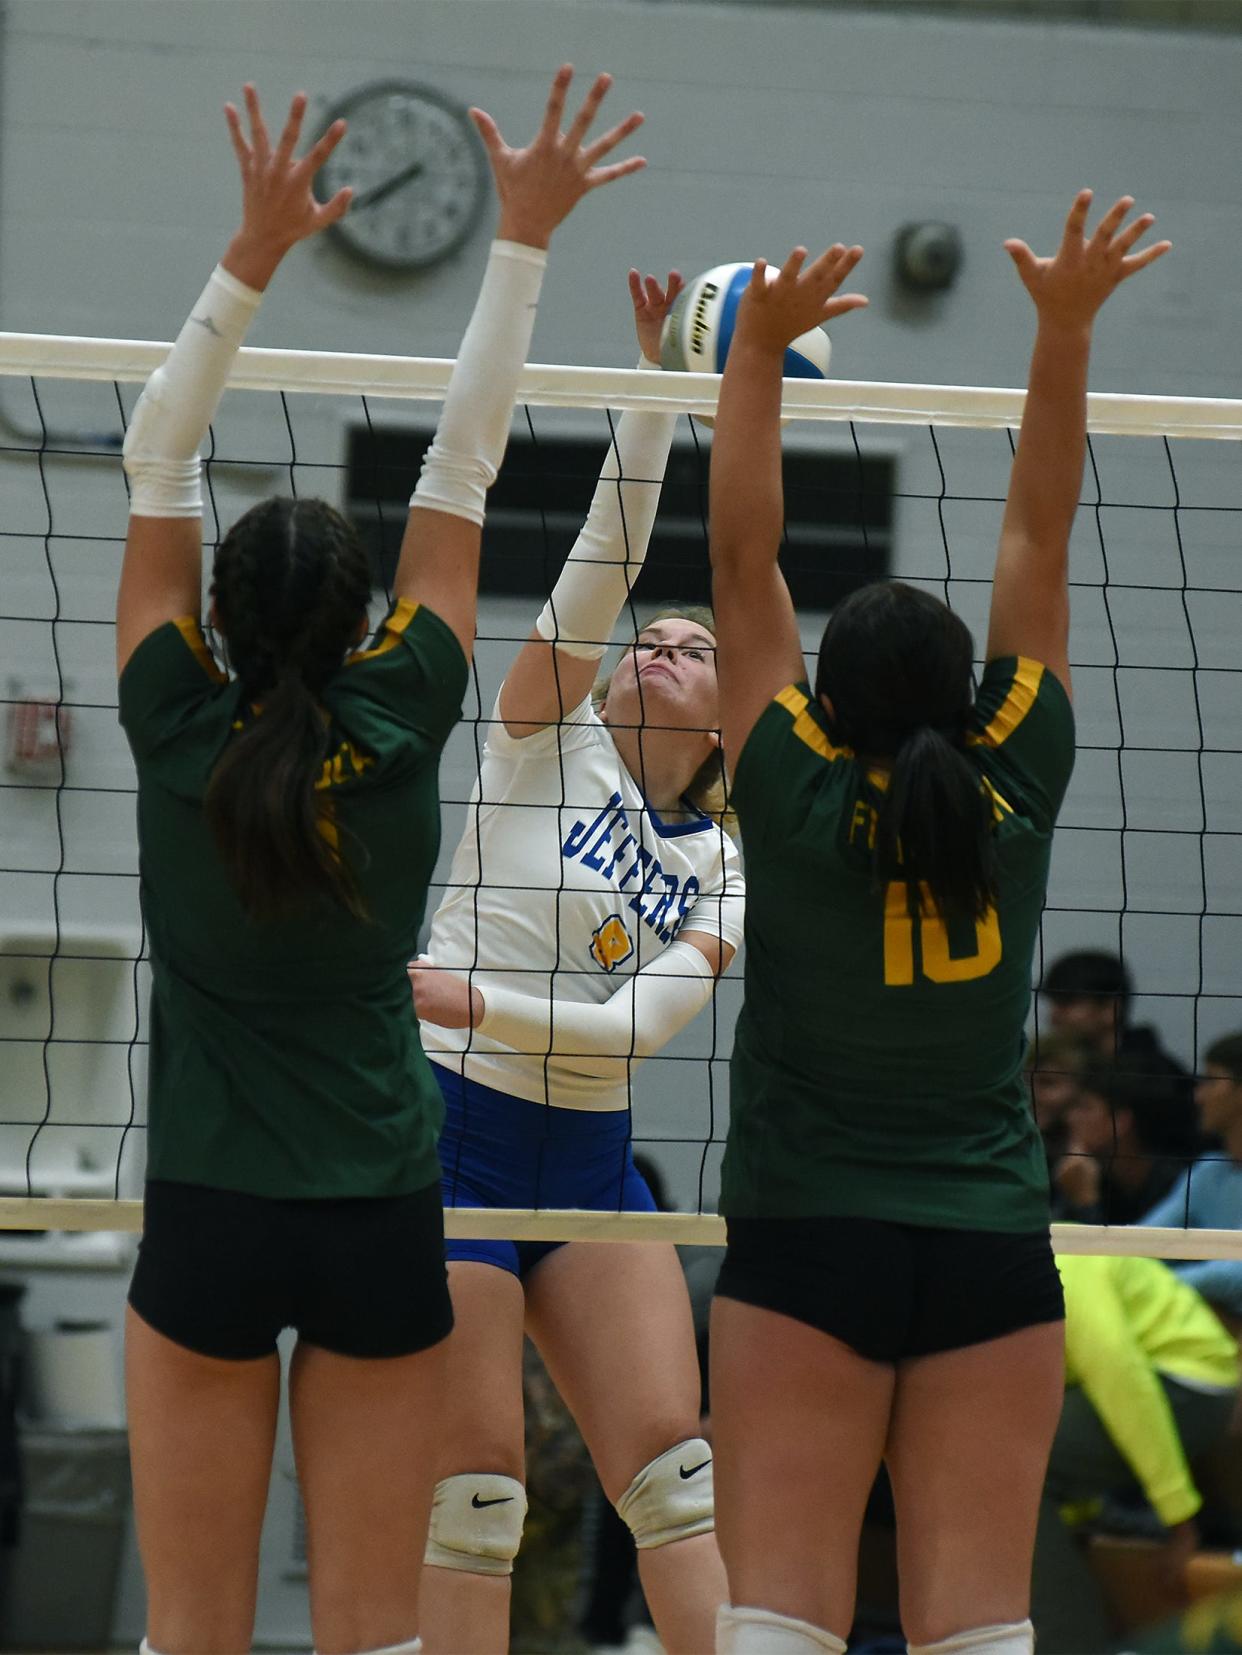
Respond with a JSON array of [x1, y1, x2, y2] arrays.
[[224, 86, 353, 288]]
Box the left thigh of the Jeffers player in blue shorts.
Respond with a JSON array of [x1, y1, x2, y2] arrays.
[[436, 1259, 525, 1481]]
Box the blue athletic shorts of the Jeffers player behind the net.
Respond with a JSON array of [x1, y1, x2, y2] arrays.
[[432, 1063, 656, 1278]]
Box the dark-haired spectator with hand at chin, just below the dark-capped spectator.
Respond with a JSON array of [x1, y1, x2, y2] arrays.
[[1052, 1058, 1196, 1225]]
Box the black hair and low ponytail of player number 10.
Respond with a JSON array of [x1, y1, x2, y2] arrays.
[[815, 581, 997, 919]]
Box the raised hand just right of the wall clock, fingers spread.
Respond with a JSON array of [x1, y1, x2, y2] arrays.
[[470, 63, 646, 247]]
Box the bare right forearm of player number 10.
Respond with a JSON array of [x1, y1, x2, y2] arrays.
[[1002, 321, 1091, 568]]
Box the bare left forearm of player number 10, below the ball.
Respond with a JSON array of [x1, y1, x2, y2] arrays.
[[710, 331, 785, 578]]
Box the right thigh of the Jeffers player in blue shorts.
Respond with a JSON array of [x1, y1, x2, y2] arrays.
[[527, 1241, 700, 1501]]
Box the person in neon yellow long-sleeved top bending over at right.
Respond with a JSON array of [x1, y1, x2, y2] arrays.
[[1030, 1256, 1239, 1655]]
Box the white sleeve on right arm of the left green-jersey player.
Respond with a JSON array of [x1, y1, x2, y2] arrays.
[[409, 242, 548, 526]]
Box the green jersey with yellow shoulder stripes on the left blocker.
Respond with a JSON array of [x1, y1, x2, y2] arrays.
[[119, 602, 467, 1197]]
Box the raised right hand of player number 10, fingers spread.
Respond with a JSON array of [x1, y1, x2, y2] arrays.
[[1005, 190, 1172, 328]]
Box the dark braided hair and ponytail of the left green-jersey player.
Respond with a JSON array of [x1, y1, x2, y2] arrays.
[[204, 500, 371, 920]]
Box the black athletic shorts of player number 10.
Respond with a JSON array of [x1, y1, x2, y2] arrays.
[[715, 1218, 1065, 1362]]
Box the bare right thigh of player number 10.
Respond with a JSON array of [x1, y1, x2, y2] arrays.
[[886, 1322, 1065, 1643]]
